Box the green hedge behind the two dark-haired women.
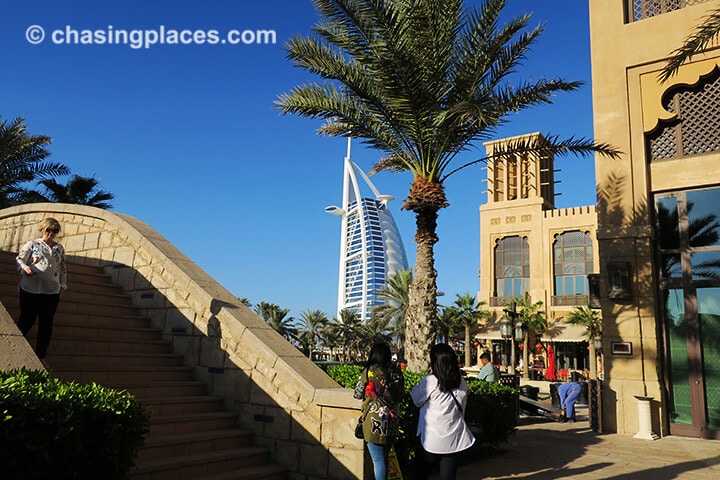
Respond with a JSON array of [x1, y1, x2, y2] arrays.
[[326, 365, 518, 462]]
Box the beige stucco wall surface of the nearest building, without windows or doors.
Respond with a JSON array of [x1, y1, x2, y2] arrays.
[[589, 0, 720, 434]]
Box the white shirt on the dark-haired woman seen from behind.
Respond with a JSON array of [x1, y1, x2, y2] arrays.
[[410, 375, 475, 454]]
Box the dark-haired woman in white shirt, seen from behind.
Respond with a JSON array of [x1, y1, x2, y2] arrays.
[[410, 343, 475, 480]]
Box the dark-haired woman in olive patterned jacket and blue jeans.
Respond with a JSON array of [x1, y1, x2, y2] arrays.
[[355, 342, 405, 480]]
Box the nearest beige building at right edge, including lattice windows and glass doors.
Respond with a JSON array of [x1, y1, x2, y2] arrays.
[[589, 0, 720, 439]]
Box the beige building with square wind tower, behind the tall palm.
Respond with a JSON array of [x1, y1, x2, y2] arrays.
[[475, 133, 598, 372]]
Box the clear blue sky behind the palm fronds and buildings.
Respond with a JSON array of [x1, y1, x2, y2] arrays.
[[0, 0, 595, 317]]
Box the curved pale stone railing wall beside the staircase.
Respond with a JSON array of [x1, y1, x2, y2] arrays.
[[0, 203, 364, 480]]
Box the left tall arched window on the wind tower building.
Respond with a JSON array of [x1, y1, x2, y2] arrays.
[[495, 236, 530, 297]]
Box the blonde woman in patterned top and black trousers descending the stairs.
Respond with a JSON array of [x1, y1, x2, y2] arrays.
[[15, 217, 67, 364]]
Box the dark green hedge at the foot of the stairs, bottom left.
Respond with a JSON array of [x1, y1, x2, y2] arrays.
[[0, 368, 150, 480]]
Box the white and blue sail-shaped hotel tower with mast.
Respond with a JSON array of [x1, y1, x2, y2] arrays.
[[325, 139, 408, 321]]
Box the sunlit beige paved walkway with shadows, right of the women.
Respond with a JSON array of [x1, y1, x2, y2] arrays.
[[448, 409, 720, 480]]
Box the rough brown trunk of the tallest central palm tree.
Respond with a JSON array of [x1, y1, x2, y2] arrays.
[[405, 209, 438, 372]]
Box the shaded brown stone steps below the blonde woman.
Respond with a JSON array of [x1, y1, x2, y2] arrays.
[[0, 252, 288, 480]]
